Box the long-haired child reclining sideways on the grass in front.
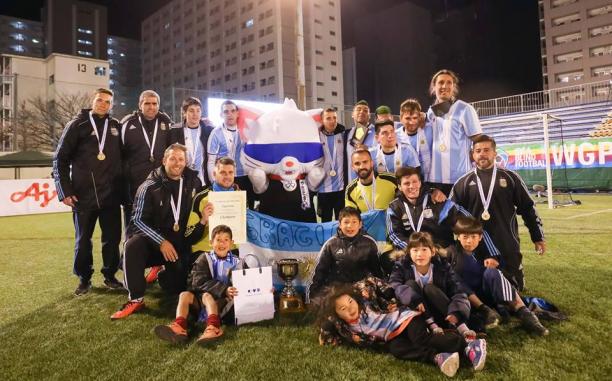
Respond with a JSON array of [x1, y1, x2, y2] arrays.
[[317, 284, 487, 377]]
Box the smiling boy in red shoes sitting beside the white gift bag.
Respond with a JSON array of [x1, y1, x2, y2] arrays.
[[154, 225, 240, 345]]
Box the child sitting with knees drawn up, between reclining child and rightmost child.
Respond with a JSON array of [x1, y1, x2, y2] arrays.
[[389, 232, 476, 340]]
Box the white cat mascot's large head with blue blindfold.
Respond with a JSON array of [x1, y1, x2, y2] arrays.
[[240, 98, 323, 181]]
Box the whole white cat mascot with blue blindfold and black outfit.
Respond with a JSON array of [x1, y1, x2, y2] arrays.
[[238, 99, 325, 222]]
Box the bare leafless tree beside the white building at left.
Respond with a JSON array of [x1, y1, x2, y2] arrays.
[[17, 93, 91, 151]]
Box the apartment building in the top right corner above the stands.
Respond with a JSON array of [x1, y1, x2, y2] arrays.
[[538, 0, 612, 99]]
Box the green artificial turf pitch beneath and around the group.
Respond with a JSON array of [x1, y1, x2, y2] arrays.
[[0, 195, 612, 380]]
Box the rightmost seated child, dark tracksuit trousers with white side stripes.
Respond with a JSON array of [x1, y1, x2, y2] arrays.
[[446, 216, 548, 336]]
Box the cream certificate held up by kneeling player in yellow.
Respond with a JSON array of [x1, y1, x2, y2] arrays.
[[208, 191, 246, 245]]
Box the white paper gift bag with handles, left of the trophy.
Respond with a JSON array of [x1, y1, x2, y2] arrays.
[[232, 254, 274, 325]]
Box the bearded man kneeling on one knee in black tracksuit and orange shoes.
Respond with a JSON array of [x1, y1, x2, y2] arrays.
[[111, 143, 201, 320]]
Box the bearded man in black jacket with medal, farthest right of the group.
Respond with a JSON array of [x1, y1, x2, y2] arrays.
[[451, 135, 546, 291]]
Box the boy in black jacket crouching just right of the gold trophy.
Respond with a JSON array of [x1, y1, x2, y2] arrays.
[[306, 206, 383, 304]]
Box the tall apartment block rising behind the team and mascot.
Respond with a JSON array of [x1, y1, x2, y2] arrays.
[[141, 0, 344, 111]]
